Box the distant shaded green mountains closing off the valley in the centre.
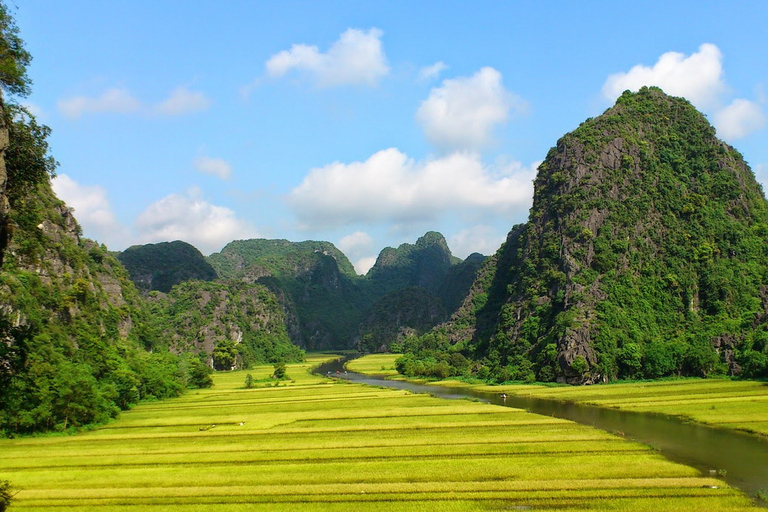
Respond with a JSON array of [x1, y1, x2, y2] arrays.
[[201, 232, 484, 352]]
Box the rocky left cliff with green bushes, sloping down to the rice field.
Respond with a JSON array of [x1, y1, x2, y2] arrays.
[[0, 182, 177, 432]]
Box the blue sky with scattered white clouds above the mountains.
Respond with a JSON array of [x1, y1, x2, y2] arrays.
[[5, 0, 768, 273]]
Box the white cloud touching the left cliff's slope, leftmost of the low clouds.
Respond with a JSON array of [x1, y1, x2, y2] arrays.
[[51, 174, 128, 245]]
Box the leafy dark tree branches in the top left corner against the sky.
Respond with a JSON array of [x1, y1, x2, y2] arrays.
[[0, 2, 32, 96]]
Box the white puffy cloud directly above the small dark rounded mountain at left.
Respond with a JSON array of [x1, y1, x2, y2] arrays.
[[135, 189, 258, 254]]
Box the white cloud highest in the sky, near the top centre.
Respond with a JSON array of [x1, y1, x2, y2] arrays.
[[266, 28, 389, 87]]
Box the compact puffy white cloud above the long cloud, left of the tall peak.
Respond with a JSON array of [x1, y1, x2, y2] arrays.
[[416, 67, 524, 150]]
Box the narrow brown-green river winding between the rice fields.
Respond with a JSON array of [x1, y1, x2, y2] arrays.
[[316, 359, 768, 502]]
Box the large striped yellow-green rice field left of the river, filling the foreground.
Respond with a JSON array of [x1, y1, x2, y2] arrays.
[[0, 356, 761, 511]]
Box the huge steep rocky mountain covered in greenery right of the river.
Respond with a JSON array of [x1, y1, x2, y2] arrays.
[[403, 88, 768, 383]]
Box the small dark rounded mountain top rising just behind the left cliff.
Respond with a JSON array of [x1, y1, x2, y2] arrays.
[[117, 240, 217, 293]]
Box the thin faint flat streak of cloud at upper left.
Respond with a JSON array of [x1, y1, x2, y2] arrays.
[[57, 87, 210, 119]]
